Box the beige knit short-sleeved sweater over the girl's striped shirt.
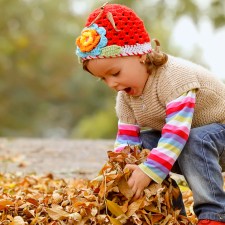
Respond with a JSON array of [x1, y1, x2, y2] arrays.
[[116, 56, 225, 130]]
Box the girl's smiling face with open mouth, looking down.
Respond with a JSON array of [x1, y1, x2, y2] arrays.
[[87, 55, 149, 96]]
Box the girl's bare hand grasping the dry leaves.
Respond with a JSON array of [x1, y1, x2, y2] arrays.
[[125, 164, 152, 200]]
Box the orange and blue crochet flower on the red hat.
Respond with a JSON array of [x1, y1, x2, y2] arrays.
[[76, 24, 108, 58]]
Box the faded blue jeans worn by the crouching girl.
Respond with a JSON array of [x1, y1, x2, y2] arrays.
[[141, 123, 225, 222]]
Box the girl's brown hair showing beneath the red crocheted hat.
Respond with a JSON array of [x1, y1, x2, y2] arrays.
[[83, 39, 168, 75]]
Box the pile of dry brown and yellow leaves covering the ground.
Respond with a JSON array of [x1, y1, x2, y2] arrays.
[[0, 148, 196, 225]]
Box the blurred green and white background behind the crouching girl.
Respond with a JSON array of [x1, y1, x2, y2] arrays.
[[0, 0, 225, 139]]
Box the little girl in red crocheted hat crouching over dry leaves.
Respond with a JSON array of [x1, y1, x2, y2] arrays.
[[76, 4, 225, 225]]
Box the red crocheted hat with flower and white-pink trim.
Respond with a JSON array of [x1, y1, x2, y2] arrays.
[[76, 3, 152, 60]]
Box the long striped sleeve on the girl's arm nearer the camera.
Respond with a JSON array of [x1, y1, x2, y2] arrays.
[[139, 90, 196, 183]]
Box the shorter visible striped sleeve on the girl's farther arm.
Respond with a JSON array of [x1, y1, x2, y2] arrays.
[[114, 122, 141, 152]]
